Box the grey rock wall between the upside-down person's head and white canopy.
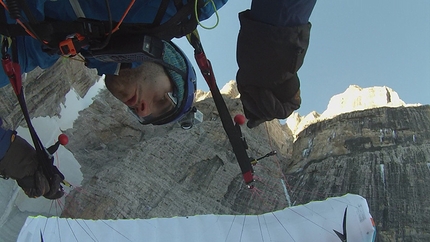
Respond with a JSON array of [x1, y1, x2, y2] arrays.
[[64, 91, 288, 218]]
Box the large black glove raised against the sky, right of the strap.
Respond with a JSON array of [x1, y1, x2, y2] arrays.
[[236, 11, 311, 128]]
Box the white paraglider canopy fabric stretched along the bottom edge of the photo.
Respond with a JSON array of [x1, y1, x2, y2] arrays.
[[17, 194, 376, 242]]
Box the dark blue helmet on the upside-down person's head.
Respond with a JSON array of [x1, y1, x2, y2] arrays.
[[91, 35, 197, 125]]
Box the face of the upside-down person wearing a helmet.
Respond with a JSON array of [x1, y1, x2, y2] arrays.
[[105, 68, 173, 117]]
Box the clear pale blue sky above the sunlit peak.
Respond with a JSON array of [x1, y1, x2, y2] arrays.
[[175, 0, 430, 115]]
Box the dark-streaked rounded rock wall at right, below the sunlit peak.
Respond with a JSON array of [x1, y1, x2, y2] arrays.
[[287, 105, 430, 241]]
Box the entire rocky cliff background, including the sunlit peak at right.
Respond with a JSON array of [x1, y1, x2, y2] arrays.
[[0, 61, 430, 241]]
